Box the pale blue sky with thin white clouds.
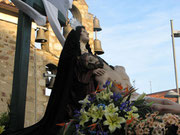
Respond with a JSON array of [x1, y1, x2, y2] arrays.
[[86, 0, 180, 94]]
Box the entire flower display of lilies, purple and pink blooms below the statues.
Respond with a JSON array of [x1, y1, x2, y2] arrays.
[[57, 81, 180, 135]]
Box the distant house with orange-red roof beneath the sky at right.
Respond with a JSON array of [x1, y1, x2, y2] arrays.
[[147, 89, 177, 102]]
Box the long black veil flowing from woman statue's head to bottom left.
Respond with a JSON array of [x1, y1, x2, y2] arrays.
[[4, 26, 91, 135]]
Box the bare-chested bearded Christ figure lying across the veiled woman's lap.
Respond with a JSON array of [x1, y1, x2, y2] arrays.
[[80, 53, 180, 114]]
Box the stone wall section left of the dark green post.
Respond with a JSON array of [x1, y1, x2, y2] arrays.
[[0, 21, 17, 115]]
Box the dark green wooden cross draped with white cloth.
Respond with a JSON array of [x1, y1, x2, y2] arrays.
[[9, 0, 66, 131]]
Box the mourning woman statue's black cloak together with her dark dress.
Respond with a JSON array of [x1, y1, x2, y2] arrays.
[[4, 30, 95, 135]]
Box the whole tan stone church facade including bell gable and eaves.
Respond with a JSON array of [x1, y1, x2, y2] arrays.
[[0, 0, 93, 126]]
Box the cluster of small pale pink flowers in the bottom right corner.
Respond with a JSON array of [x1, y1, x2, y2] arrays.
[[128, 112, 180, 135]]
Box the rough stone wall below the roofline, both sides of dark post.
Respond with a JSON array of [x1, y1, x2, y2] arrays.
[[0, 21, 58, 126]]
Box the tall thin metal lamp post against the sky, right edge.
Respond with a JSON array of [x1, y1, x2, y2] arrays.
[[170, 20, 180, 104]]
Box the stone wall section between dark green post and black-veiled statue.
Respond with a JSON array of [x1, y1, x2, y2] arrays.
[[25, 47, 58, 126]]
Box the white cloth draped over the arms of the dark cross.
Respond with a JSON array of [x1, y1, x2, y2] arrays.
[[12, 0, 73, 46]]
